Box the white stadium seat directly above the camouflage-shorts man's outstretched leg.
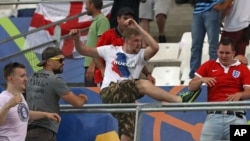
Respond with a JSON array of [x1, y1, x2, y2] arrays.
[[152, 66, 181, 86]]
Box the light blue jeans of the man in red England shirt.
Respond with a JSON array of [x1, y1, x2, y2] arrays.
[[200, 114, 247, 141]]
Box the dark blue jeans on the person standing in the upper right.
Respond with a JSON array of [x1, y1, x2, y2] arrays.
[[189, 9, 220, 78]]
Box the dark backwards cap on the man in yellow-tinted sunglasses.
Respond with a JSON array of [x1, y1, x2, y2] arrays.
[[37, 47, 63, 67]]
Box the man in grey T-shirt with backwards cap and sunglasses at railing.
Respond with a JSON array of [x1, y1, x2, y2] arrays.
[[26, 47, 87, 141]]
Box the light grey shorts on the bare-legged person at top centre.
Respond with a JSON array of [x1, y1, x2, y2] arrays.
[[139, 0, 172, 20]]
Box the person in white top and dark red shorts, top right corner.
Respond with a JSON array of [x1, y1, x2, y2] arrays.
[[222, 0, 250, 65]]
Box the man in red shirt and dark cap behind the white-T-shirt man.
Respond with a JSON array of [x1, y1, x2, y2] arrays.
[[95, 7, 155, 84]]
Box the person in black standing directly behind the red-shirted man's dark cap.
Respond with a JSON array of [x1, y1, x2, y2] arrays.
[[109, 0, 146, 28]]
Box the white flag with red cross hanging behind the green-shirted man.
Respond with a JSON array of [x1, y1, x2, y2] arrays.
[[25, 1, 112, 58]]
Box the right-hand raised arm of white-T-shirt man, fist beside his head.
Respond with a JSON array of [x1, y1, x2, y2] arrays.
[[125, 19, 159, 60]]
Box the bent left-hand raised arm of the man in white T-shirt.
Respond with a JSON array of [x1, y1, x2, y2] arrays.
[[69, 29, 100, 57]]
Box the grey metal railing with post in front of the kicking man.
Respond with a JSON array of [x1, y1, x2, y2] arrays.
[[60, 101, 250, 141]]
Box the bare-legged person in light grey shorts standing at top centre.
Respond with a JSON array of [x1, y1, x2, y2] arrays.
[[139, 0, 172, 43]]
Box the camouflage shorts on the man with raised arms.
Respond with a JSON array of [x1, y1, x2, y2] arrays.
[[100, 80, 143, 138]]
